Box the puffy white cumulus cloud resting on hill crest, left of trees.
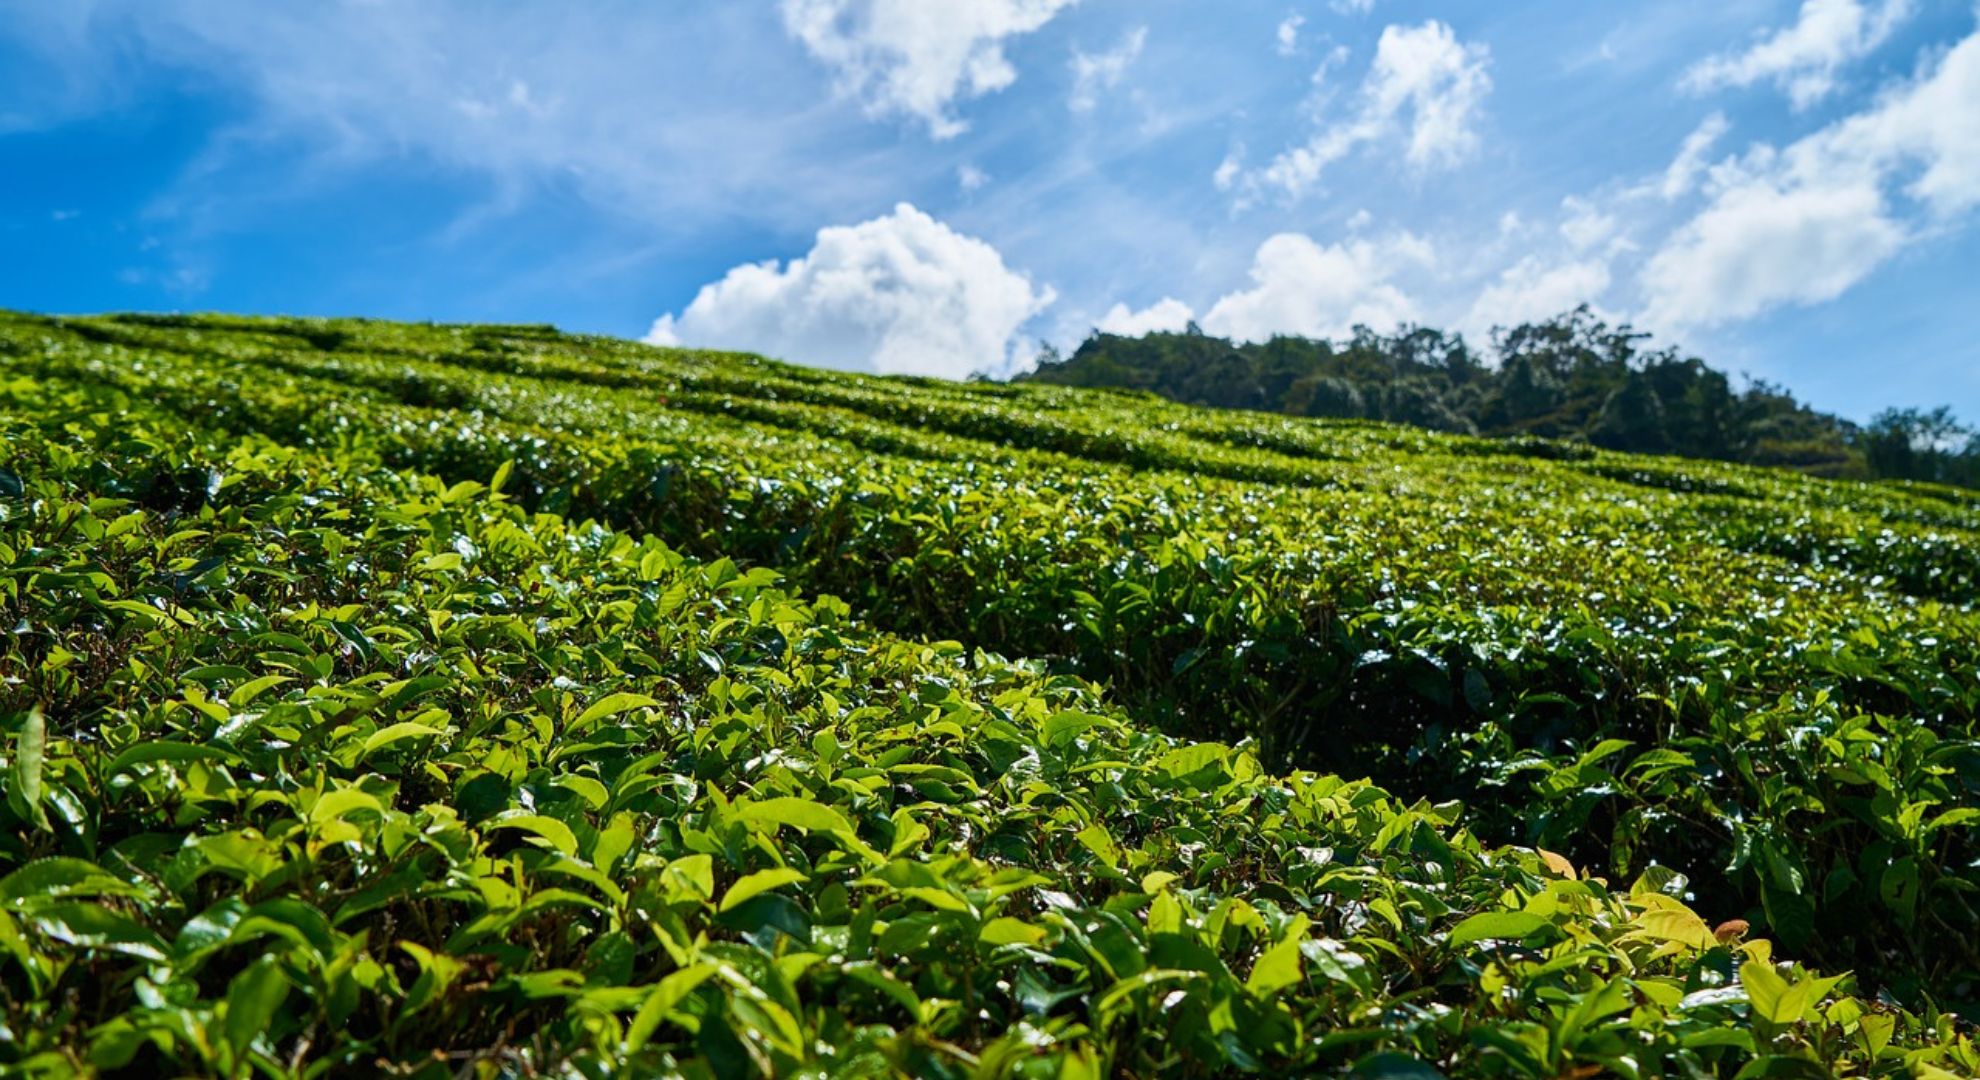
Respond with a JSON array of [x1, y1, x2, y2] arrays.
[[647, 202, 1053, 378]]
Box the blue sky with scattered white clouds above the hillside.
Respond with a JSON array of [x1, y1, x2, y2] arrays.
[[0, 0, 1980, 418]]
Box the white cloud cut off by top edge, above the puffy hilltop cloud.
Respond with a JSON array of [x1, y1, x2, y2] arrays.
[[782, 0, 1075, 139]]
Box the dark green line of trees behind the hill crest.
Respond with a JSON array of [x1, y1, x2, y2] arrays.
[[1016, 305, 1980, 487]]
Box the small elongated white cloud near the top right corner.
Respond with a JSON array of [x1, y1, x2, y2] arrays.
[[1681, 0, 1913, 109]]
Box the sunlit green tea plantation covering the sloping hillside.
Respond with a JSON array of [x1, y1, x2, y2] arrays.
[[0, 313, 1980, 1078]]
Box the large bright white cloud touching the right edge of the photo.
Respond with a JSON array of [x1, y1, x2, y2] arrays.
[[1643, 34, 1980, 327]]
